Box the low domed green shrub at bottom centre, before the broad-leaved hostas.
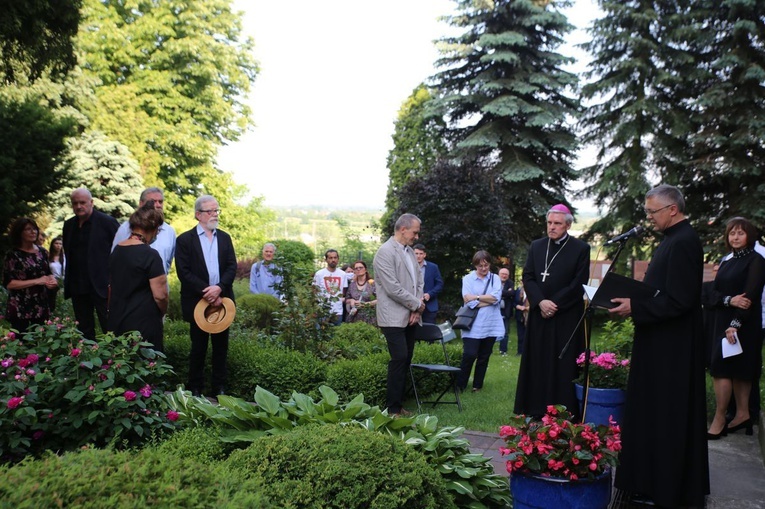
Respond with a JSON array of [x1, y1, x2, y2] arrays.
[[227, 425, 456, 509]]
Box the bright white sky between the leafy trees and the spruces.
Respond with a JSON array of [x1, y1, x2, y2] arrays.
[[218, 0, 597, 210]]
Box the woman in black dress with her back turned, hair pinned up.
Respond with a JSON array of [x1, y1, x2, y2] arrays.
[[109, 200, 168, 352]]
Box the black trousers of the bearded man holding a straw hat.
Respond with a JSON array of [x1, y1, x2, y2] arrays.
[[187, 322, 228, 393]]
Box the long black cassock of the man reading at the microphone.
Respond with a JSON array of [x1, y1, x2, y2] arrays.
[[615, 220, 709, 507]]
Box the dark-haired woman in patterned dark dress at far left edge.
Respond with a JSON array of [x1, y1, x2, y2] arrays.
[[3, 217, 58, 332]]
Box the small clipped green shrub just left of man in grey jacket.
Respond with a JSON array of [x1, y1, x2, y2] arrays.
[[326, 353, 390, 407]]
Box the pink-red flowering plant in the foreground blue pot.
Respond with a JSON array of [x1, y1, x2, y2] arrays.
[[499, 405, 622, 480]]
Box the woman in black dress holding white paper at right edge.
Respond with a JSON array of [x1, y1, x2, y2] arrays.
[[707, 217, 765, 440]]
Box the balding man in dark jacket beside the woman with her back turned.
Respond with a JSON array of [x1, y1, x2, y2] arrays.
[[63, 187, 119, 339]]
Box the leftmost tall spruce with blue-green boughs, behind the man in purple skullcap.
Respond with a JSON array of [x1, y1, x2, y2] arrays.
[[432, 0, 579, 243]]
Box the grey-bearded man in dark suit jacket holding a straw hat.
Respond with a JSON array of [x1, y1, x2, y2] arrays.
[[175, 195, 236, 396]]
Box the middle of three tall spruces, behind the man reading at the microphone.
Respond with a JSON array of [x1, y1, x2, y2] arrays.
[[580, 0, 694, 246]]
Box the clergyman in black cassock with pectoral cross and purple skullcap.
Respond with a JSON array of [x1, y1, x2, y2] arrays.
[[515, 204, 590, 417]]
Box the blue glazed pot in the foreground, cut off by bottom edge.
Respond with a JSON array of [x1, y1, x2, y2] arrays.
[[510, 470, 611, 509]]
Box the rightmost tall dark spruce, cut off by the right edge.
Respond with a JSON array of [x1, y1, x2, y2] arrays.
[[678, 0, 765, 252]]
